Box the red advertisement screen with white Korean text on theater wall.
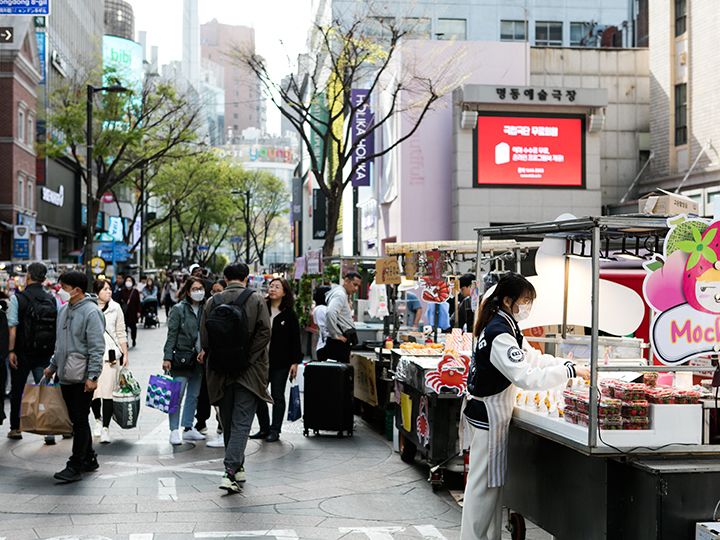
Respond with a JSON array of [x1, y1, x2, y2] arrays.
[[475, 115, 585, 188]]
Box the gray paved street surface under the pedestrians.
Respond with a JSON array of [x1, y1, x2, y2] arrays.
[[0, 318, 549, 540]]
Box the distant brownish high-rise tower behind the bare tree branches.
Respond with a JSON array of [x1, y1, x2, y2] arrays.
[[200, 19, 265, 137]]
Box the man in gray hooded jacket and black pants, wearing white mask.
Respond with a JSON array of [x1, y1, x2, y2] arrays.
[[45, 272, 105, 483]]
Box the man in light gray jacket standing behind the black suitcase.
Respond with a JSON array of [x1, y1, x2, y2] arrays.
[[318, 272, 362, 364]]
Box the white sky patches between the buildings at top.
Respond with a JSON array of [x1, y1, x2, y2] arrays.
[[128, 0, 311, 133]]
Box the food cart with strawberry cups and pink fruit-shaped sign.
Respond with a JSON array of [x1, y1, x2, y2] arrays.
[[477, 216, 720, 540]]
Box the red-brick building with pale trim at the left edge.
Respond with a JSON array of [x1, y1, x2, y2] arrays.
[[0, 16, 42, 261]]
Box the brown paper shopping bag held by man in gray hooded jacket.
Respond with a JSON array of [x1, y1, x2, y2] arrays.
[[20, 379, 72, 435]]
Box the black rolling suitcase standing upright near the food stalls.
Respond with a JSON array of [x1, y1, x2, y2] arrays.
[[303, 361, 355, 437]]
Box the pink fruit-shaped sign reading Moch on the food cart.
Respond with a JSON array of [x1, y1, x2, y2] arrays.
[[643, 216, 720, 365]]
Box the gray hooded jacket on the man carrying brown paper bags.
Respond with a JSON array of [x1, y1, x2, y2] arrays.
[[50, 295, 105, 384]]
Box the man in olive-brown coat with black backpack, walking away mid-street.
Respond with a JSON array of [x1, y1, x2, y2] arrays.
[[198, 263, 272, 493]]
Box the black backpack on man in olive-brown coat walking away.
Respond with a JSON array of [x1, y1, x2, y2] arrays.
[[205, 289, 253, 376]]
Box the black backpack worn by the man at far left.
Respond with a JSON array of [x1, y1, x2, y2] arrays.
[[21, 291, 57, 357]]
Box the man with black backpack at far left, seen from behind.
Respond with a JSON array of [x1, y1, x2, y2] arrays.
[[7, 262, 57, 444]]
